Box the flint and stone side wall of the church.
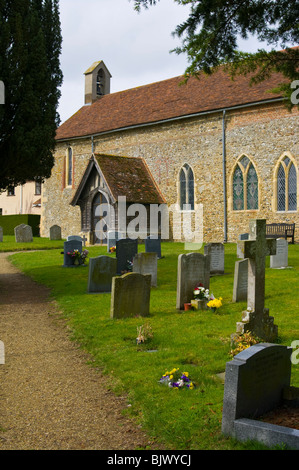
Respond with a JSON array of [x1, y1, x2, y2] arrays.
[[41, 104, 299, 242]]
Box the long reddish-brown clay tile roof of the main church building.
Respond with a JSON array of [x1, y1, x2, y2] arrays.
[[56, 68, 284, 140]]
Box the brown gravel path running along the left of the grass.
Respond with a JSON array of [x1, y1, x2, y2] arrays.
[[0, 253, 153, 450]]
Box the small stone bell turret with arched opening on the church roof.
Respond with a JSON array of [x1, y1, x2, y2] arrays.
[[84, 60, 112, 104]]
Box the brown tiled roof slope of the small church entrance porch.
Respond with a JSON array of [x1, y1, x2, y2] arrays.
[[94, 154, 165, 204]]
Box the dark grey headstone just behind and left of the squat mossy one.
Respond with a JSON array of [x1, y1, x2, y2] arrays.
[[87, 256, 117, 293]]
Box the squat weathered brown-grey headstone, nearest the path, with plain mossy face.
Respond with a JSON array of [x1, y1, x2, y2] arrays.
[[110, 273, 151, 318]]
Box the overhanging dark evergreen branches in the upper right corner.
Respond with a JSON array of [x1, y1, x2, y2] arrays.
[[134, 0, 299, 106]]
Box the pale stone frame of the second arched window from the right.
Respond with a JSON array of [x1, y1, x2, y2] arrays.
[[228, 153, 261, 213]]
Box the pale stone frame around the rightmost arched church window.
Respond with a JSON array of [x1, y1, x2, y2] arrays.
[[272, 151, 299, 214]]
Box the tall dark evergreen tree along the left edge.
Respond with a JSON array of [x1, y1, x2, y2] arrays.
[[0, 0, 62, 190]]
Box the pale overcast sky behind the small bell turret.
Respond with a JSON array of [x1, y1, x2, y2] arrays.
[[58, 0, 278, 122]]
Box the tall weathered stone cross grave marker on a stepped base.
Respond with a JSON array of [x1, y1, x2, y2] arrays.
[[237, 219, 278, 342]]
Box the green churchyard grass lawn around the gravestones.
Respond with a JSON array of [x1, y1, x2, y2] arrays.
[[3, 243, 299, 450]]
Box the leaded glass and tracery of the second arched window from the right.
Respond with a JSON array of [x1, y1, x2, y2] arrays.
[[232, 155, 258, 211]]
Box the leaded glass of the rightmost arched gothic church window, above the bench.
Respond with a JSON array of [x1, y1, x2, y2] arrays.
[[277, 156, 297, 211]]
